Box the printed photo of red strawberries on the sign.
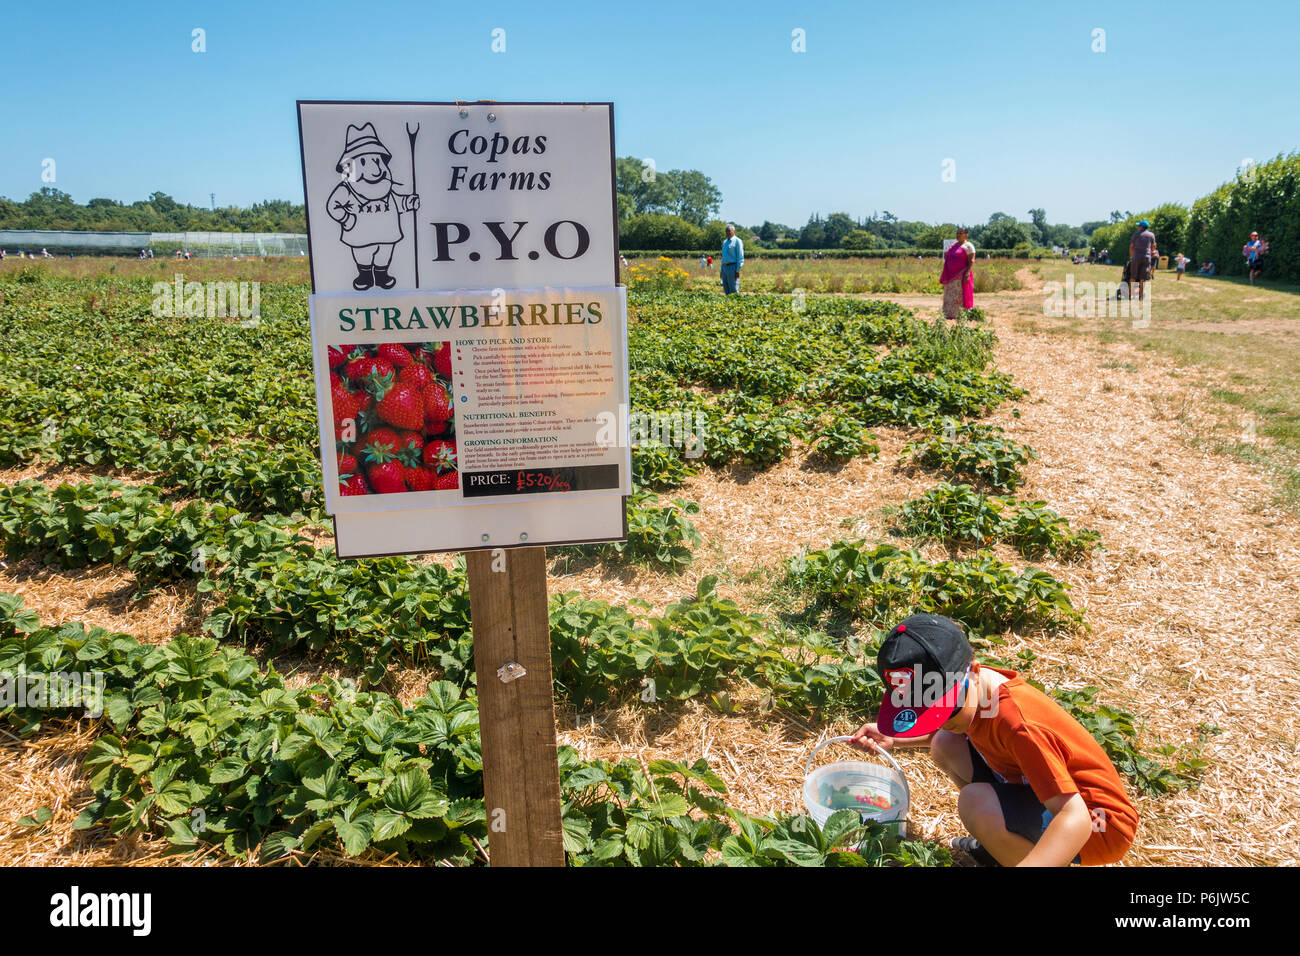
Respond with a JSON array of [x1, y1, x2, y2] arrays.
[[329, 342, 460, 496]]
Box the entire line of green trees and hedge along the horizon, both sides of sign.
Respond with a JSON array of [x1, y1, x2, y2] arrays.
[[12, 153, 1300, 280]]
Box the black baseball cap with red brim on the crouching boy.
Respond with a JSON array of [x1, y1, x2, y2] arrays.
[[876, 614, 974, 737]]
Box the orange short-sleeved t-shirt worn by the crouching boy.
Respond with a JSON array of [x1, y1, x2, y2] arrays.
[[966, 665, 1138, 866]]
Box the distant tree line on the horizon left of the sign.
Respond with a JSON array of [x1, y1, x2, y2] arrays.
[[0, 186, 307, 233]]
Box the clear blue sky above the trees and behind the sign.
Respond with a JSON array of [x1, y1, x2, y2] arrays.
[[0, 0, 1300, 225]]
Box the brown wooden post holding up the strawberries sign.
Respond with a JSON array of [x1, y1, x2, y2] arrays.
[[465, 548, 564, 866]]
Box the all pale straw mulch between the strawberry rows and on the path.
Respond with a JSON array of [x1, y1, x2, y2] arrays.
[[0, 283, 1300, 865]]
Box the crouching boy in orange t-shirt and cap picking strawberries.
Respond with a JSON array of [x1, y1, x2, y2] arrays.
[[852, 614, 1138, 866]]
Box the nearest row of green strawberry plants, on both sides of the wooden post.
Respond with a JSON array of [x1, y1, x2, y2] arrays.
[[0, 594, 945, 866]]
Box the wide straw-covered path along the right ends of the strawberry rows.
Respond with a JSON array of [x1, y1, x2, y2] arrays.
[[995, 317, 1300, 865]]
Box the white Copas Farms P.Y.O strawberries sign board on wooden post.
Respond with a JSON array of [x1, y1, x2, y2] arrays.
[[298, 101, 631, 557]]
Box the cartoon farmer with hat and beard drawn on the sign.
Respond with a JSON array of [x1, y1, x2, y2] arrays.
[[326, 122, 420, 290]]
